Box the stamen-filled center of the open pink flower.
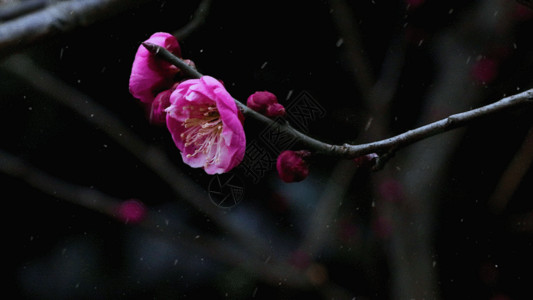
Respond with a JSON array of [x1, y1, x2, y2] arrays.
[[180, 105, 223, 166]]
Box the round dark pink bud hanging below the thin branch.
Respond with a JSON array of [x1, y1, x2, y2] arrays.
[[276, 150, 311, 182]]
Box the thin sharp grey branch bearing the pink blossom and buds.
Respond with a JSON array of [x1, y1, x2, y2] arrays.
[[143, 43, 533, 159]]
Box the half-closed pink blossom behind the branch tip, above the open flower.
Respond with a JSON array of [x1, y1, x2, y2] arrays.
[[129, 32, 181, 103]]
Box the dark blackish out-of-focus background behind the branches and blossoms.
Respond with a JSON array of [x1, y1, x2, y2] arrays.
[[0, 0, 533, 299]]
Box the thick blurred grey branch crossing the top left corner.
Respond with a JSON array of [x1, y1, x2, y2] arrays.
[[0, 0, 148, 57]]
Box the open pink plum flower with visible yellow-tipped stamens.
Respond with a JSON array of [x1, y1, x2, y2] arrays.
[[166, 76, 246, 174]]
